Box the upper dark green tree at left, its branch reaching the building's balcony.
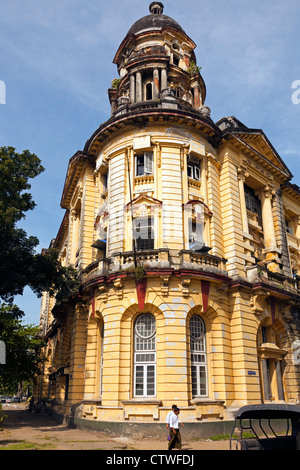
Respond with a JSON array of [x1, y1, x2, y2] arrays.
[[0, 147, 79, 304]]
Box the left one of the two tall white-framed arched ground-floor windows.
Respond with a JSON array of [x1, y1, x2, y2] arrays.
[[134, 313, 156, 397]]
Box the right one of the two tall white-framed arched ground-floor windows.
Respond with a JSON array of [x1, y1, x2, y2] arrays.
[[190, 315, 208, 397]]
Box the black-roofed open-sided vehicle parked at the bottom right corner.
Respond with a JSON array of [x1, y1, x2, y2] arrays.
[[230, 404, 300, 450]]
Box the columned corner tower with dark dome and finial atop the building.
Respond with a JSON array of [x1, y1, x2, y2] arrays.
[[109, 2, 205, 116]]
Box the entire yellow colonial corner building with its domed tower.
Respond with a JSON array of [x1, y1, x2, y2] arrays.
[[36, 2, 300, 422]]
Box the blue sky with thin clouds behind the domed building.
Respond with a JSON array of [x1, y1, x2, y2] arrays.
[[0, 0, 300, 324]]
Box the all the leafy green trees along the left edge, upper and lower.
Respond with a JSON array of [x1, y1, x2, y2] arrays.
[[0, 147, 79, 393]]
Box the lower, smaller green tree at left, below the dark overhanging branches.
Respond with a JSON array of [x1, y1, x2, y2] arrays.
[[0, 303, 43, 395]]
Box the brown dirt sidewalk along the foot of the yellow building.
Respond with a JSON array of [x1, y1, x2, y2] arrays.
[[0, 404, 229, 452]]
